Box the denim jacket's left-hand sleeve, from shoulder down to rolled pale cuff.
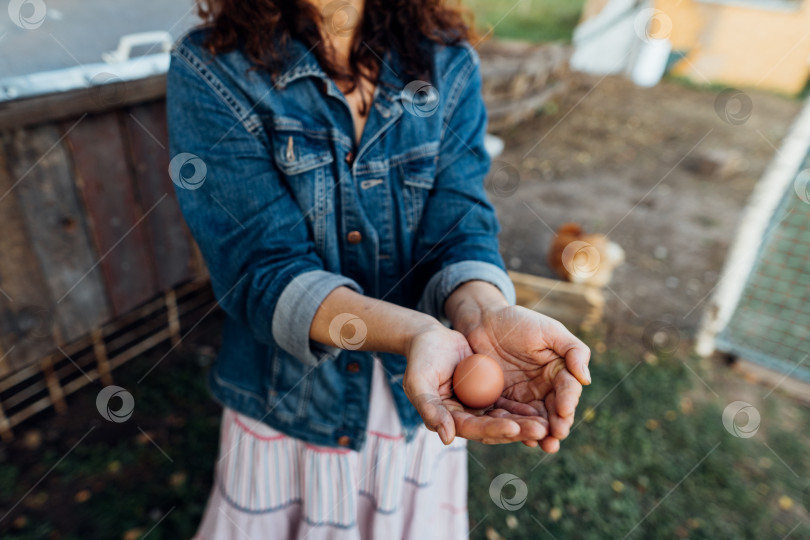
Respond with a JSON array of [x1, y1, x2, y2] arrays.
[[167, 50, 362, 365]]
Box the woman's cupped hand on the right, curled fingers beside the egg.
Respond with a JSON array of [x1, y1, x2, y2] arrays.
[[462, 306, 591, 452]]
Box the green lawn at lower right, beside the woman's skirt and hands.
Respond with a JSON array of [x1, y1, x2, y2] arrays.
[[469, 353, 810, 540]]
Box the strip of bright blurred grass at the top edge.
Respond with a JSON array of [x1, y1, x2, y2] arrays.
[[462, 0, 585, 42]]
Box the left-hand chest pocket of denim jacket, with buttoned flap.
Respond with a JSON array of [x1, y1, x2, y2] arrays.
[[272, 126, 335, 255]]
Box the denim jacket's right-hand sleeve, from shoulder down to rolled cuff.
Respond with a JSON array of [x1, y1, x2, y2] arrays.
[[415, 46, 515, 318]]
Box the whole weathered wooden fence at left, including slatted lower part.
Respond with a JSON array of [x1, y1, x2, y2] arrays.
[[0, 77, 211, 438]]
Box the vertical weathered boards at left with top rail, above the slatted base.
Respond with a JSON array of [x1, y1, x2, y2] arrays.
[[0, 82, 205, 376]]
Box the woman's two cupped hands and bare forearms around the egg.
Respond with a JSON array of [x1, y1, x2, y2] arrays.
[[310, 281, 590, 452]]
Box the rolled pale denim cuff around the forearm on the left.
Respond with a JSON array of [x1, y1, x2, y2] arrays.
[[272, 270, 363, 366]]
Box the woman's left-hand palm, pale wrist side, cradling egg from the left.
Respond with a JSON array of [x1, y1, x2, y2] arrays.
[[403, 324, 549, 444]]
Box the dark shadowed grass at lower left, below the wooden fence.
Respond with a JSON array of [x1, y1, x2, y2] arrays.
[[0, 338, 221, 540]]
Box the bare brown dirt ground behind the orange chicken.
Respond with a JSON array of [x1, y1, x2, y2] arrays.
[[490, 74, 801, 334]]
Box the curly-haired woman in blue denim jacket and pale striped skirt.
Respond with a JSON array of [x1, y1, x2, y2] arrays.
[[168, 0, 590, 540]]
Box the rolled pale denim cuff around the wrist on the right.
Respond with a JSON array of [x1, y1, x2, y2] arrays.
[[418, 261, 515, 320]]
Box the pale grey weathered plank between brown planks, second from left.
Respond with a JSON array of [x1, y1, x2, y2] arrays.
[[6, 123, 110, 341]]
